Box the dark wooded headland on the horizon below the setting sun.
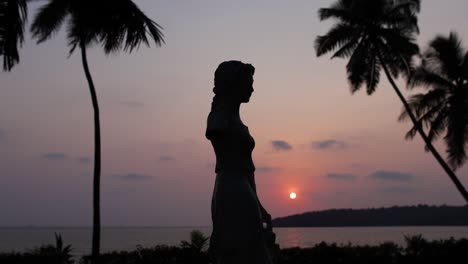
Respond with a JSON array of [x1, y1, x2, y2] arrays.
[[273, 205, 468, 227]]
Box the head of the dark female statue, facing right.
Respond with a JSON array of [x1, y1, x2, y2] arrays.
[[213, 61, 255, 103]]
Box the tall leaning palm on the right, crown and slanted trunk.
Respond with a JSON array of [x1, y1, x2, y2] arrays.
[[315, 0, 468, 203]]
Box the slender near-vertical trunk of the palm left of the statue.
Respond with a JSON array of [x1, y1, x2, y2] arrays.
[[80, 43, 101, 264]]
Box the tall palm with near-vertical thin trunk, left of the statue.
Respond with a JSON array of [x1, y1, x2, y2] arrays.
[[31, 0, 164, 262]]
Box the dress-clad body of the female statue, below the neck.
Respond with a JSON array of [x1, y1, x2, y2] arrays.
[[206, 111, 272, 264]]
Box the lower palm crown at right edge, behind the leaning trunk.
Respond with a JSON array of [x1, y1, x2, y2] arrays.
[[400, 32, 468, 170]]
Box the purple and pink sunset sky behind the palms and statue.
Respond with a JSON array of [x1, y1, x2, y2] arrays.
[[0, 0, 468, 226]]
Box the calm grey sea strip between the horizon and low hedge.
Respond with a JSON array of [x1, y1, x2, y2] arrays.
[[0, 226, 468, 256]]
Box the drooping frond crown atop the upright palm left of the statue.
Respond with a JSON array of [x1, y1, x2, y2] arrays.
[[31, 0, 164, 54]]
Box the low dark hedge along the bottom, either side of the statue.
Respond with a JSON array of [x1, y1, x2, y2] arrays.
[[0, 235, 468, 264]]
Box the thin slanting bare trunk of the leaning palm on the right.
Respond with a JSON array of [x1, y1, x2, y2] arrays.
[[378, 52, 468, 203]]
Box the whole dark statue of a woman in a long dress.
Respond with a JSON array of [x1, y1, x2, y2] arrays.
[[206, 61, 277, 264]]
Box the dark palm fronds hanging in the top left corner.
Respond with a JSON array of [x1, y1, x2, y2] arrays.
[[0, 0, 28, 71]]
